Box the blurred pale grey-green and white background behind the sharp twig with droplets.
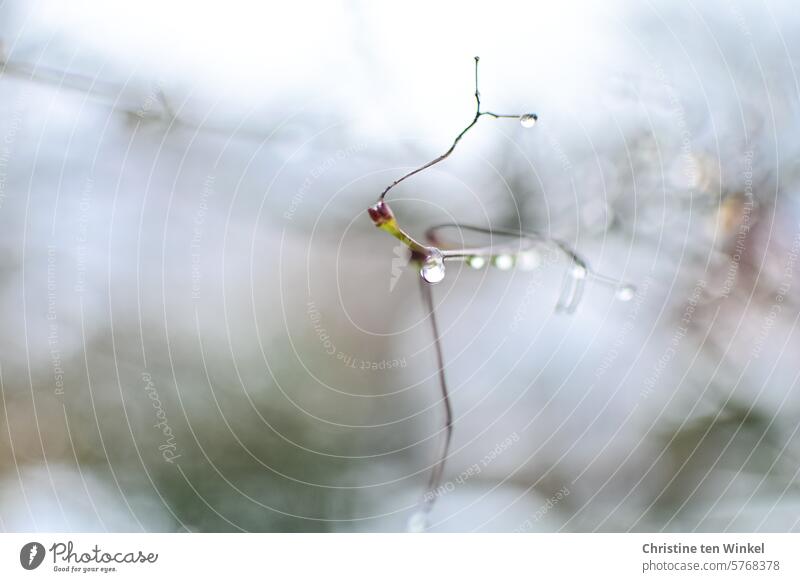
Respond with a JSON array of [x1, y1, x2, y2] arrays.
[[0, 0, 800, 532]]
